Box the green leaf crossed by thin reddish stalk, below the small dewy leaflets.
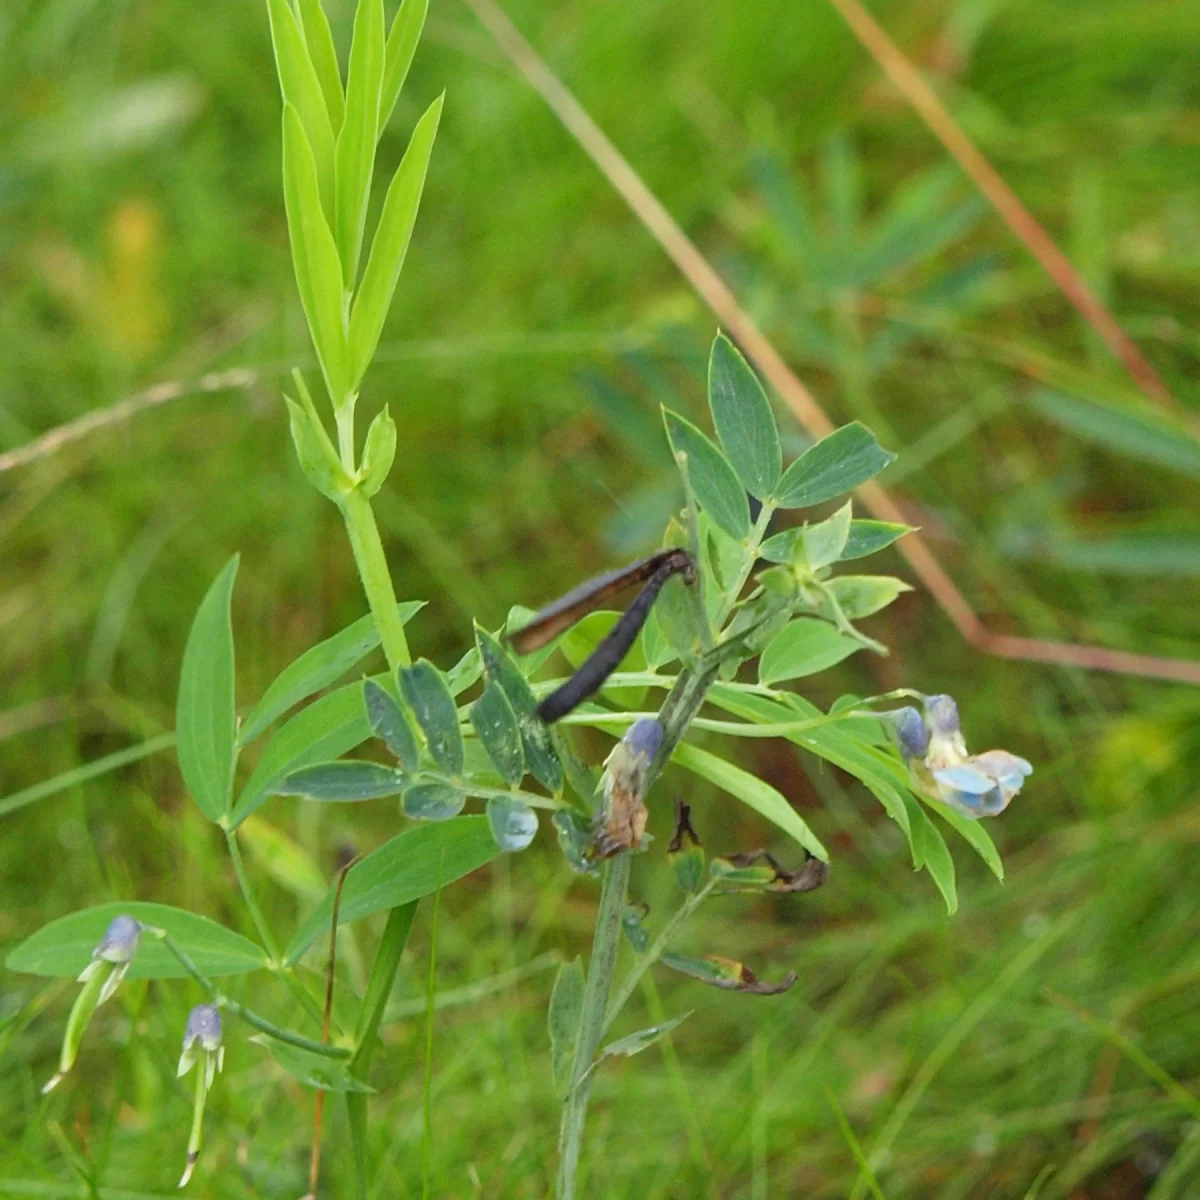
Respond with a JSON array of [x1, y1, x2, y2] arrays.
[[284, 816, 500, 965]]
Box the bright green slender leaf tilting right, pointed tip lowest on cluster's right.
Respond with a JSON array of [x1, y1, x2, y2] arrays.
[[349, 96, 443, 388]]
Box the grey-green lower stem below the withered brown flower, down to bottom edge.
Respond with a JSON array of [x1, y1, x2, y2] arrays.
[[554, 854, 632, 1200]]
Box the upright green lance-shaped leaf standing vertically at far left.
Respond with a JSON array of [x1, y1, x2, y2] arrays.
[[175, 554, 238, 821]]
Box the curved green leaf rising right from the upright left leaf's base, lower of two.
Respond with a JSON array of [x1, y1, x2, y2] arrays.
[[233, 682, 371, 826]]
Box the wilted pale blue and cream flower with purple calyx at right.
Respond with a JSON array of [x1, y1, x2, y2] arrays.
[[880, 695, 1033, 817]]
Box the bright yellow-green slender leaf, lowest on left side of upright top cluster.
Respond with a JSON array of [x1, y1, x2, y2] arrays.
[[283, 104, 356, 406]]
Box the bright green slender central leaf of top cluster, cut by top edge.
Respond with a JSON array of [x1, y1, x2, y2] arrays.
[[334, 0, 384, 288]]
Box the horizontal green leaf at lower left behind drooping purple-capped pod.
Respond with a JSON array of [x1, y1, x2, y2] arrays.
[[5, 900, 268, 979]]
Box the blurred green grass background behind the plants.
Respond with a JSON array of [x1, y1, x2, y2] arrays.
[[0, 0, 1200, 1200]]
